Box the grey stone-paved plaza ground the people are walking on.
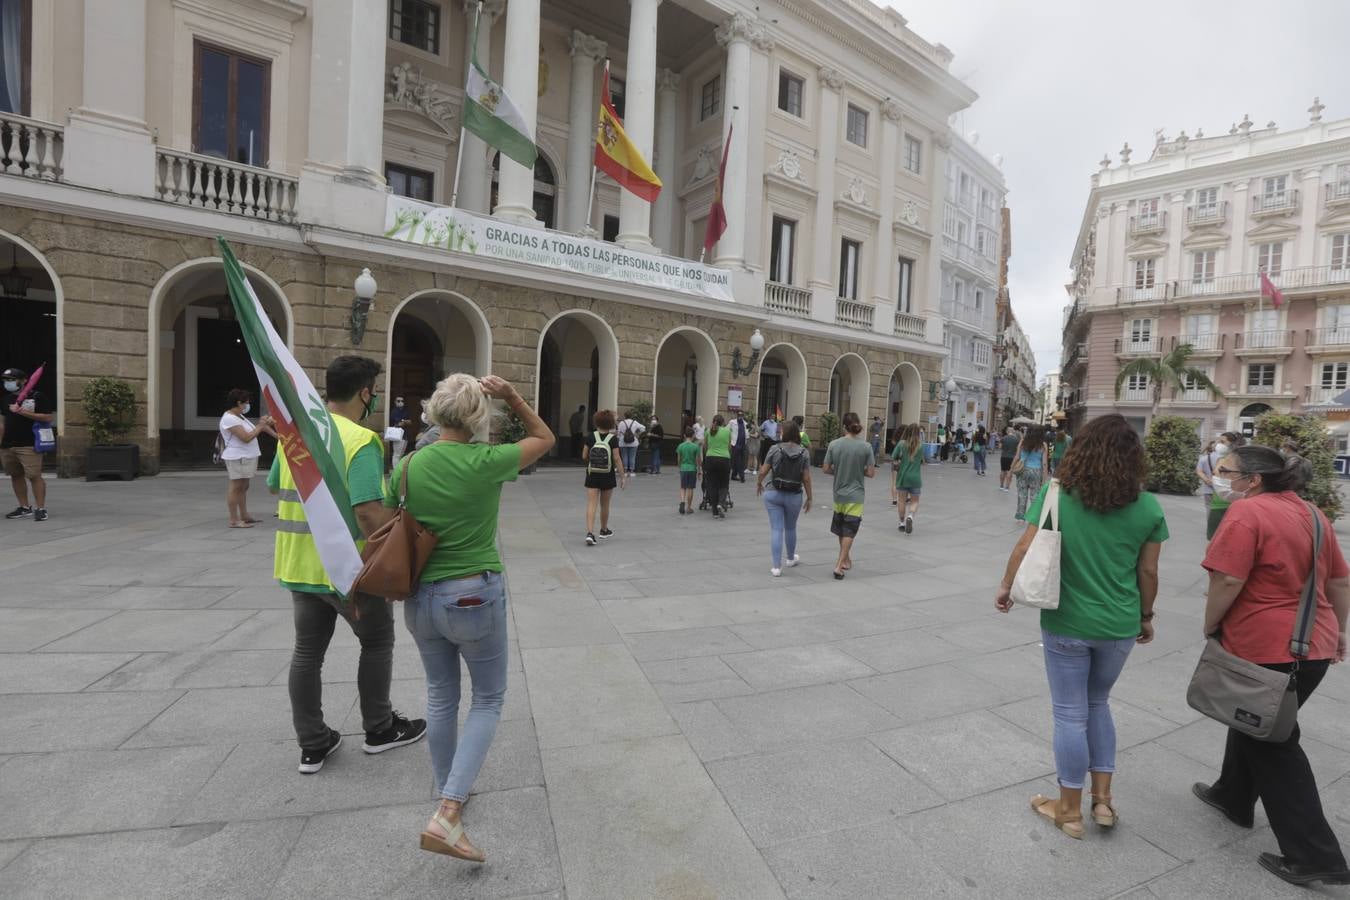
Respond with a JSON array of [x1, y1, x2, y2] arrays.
[[0, 467, 1350, 900]]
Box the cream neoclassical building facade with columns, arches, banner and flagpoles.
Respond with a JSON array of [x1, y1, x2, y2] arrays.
[[0, 0, 992, 474]]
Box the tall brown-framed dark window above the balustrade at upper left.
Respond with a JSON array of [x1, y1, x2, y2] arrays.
[[192, 40, 271, 166]]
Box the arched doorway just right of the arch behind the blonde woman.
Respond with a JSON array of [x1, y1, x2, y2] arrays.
[[535, 309, 622, 457]]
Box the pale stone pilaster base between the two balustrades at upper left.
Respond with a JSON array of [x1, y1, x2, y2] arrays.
[[63, 0, 154, 197]]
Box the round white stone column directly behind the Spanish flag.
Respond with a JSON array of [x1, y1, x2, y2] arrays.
[[617, 0, 661, 250]]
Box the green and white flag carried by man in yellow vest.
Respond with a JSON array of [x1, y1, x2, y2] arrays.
[[216, 237, 362, 596]]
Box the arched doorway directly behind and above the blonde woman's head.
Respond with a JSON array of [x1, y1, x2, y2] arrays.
[[385, 290, 491, 447]]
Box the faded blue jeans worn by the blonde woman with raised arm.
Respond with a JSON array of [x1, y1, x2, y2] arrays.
[[404, 572, 506, 801]]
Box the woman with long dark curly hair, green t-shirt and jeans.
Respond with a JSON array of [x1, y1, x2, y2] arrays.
[[994, 416, 1168, 838]]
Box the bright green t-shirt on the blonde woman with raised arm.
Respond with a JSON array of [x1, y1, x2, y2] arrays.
[[385, 441, 520, 582]]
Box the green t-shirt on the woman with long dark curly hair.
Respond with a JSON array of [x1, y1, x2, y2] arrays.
[[1026, 484, 1168, 641]]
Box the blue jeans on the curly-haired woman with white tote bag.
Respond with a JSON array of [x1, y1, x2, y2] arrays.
[[1041, 630, 1134, 788]]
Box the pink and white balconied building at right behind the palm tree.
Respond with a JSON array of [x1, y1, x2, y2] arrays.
[[1061, 101, 1350, 440]]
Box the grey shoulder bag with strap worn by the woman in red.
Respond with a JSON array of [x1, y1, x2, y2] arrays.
[[1185, 503, 1322, 743]]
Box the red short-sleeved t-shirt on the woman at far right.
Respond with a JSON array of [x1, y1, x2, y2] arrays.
[[1202, 491, 1350, 663]]
